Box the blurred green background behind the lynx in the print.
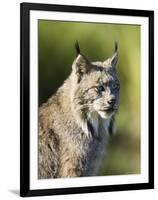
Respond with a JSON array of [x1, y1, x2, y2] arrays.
[[38, 20, 140, 175]]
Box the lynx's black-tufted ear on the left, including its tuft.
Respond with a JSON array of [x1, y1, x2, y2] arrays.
[[72, 42, 90, 82]]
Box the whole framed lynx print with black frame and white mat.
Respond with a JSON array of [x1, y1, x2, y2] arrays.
[[20, 3, 154, 197]]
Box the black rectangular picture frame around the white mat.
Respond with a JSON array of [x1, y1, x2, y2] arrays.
[[20, 3, 154, 197]]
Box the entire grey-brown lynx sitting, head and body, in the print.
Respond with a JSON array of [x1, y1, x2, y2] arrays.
[[38, 43, 119, 178]]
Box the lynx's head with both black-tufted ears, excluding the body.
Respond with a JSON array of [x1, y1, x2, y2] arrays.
[[71, 43, 120, 137]]
